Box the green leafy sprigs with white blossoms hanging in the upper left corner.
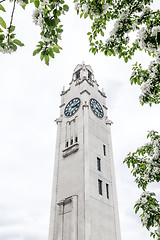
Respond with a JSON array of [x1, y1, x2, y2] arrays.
[[0, 0, 69, 65]]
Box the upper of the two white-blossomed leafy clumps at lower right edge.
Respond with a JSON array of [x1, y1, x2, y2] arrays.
[[124, 131, 160, 190]]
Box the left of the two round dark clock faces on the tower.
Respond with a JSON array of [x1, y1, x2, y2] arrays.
[[64, 98, 81, 117]]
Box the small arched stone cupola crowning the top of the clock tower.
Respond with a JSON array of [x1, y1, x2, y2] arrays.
[[72, 61, 95, 85]]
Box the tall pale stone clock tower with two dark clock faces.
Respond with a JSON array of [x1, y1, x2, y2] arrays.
[[49, 63, 121, 240]]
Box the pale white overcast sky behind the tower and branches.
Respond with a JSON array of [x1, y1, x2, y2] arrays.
[[0, 0, 160, 240]]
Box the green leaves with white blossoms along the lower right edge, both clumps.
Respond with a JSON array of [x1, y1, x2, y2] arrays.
[[124, 131, 160, 239]]
